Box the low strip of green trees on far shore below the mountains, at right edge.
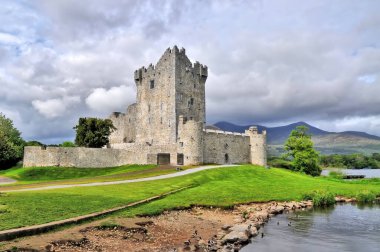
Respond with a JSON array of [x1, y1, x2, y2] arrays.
[[320, 153, 380, 169]]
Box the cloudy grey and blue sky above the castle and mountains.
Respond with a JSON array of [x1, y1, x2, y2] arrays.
[[0, 0, 380, 143]]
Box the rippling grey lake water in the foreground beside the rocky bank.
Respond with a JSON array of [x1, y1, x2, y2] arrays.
[[242, 204, 380, 252]]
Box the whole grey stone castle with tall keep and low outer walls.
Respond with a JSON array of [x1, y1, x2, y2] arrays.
[[24, 46, 266, 167]]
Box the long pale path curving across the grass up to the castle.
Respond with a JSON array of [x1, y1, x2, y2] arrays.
[[0, 165, 239, 192]]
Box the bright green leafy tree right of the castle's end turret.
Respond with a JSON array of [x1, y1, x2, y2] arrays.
[[284, 126, 322, 176]]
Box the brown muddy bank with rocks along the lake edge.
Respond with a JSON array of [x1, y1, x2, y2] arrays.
[[0, 201, 312, 251]]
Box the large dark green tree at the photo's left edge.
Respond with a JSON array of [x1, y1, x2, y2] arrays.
[[0, 113, 25, 168]]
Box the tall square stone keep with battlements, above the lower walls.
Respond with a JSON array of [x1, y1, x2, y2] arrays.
[[134, 46, 207, 145]]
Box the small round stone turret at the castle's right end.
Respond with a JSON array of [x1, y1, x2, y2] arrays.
[[245, 126, 267, 166]]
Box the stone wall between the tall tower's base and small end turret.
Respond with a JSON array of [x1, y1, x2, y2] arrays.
[[203, 129, 250, 164]]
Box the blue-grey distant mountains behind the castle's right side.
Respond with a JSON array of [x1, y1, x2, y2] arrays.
[[214, 122, 380, 155]]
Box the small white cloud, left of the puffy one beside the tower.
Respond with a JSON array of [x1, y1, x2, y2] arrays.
[[32, 96, 80, 118]]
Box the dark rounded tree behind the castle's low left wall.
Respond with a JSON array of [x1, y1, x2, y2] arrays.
[[74, 118, 116, 148]]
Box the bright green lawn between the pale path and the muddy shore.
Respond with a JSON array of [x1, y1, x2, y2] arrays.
[[0, 165, 380, 230]]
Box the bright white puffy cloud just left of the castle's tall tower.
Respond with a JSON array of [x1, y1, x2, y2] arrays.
[[86, 85, 136, 113]]
